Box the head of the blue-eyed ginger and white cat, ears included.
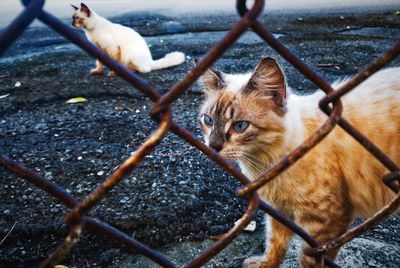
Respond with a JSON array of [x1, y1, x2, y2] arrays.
[[199, 58, 286, 162]]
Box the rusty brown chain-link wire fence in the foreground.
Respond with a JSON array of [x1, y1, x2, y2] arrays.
[[0, 0, 400, 267]]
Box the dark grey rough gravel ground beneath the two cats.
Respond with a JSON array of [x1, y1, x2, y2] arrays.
[[0, 6, 400, 267]]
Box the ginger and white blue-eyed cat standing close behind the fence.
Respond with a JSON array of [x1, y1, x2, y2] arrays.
[[200, 58, 400, 267]]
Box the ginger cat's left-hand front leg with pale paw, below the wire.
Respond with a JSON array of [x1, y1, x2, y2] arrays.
[[243, 216, 293, 268]]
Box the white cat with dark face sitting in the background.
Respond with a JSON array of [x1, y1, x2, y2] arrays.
[[72, 3, 185, 76]]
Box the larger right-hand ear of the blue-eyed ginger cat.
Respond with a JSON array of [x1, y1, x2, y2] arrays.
[[243, 57, 286, 107]]
